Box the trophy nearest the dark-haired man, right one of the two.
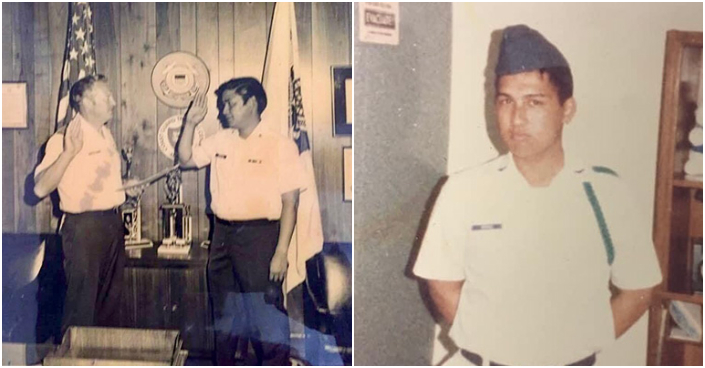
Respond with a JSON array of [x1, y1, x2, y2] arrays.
[[157, 170, 192, 255]]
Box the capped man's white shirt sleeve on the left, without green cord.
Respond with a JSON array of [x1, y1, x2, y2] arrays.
[[414, 184, 465, 281]]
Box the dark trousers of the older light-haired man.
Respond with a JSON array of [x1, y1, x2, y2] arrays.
[[61, 210, 125, 334]]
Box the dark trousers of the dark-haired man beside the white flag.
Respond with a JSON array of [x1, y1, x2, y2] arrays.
[[208, 219, 289, 365]]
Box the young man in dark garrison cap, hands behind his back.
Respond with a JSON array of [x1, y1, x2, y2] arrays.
[[414, 25, 661, 365]]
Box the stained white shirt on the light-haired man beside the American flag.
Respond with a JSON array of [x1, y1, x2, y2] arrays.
[[34, 114, 125, 213]]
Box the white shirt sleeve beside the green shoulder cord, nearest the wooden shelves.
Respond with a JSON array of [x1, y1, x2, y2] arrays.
[[598, 179, 662, 290]]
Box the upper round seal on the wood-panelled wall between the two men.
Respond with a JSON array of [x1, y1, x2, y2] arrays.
[[152, 51, 210, 108]]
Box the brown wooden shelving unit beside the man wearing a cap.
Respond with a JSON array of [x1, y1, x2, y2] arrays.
[[647, 31, 703, 366]]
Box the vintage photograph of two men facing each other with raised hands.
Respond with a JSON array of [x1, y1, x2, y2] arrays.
[[2, 2, 353, 366]]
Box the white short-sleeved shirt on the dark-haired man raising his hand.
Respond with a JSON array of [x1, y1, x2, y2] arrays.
[[192, 122, 305, 221]]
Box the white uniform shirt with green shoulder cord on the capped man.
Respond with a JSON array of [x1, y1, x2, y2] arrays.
[[414, 155, 661, 365]]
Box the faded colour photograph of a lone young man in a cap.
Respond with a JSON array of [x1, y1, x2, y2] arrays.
[[354, 3, 703, 366]]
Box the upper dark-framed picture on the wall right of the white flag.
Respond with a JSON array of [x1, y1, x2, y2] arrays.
[[331, 66, 352, 136]]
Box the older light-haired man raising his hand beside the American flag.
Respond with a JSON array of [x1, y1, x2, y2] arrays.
[[34, 75, 141, 333]]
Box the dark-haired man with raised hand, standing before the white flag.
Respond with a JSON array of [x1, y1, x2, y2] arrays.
[[177, 78, 304, 365]]
